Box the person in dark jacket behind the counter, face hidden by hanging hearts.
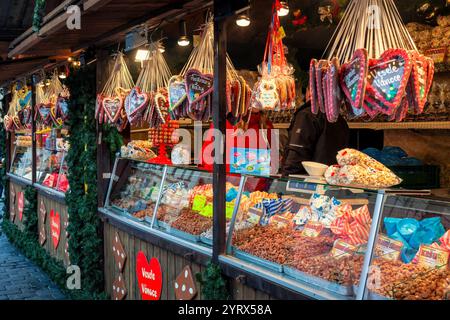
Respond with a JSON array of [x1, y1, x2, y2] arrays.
[[281, 89, 350, 176]]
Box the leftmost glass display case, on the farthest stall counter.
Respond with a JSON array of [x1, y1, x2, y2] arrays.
[[9, 131, 33, 181]]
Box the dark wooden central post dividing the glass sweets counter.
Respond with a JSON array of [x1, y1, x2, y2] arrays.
[[212, 5, 227, 263]]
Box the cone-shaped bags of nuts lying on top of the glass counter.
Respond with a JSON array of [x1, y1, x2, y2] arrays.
[[325, 149, 402, 189]]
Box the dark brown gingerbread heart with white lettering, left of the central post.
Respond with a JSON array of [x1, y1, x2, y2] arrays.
[[185, 69, 214, 105]]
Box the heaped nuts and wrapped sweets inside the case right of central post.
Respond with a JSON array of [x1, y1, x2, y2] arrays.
[[233, 190, 450, 299]]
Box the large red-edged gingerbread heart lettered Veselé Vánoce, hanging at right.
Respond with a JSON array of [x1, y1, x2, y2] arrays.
[[367, 49, 412, 115]]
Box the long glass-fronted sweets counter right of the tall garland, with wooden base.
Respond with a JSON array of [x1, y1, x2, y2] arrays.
[[99, 158, 450, 299]]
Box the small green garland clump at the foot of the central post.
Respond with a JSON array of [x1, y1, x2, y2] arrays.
[[195, 262, 231, 300]]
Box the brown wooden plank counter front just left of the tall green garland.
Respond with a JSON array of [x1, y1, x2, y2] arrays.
[[36, 192, 69, 266]]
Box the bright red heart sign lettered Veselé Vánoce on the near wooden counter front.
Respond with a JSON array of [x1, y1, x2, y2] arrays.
[[136, 251, 162, 300]]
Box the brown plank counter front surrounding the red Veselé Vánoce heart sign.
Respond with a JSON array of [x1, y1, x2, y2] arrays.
[[103, 223, 270, 300]]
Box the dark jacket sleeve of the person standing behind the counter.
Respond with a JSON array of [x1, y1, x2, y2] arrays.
[[281, 110, 321, 176]]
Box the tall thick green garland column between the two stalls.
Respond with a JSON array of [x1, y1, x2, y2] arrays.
[[66, 65, 104, 294]]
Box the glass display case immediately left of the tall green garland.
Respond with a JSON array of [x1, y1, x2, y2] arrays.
[[36, 129, 69, 193]]
